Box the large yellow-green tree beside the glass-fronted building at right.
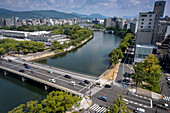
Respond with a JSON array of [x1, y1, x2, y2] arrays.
[[132, 54, 162, 90]]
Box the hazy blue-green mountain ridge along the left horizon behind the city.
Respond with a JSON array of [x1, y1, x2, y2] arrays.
[[0, 8, 109, 19]]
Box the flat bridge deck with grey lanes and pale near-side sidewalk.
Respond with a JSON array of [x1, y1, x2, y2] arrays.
[[0, 59, 93, 96]]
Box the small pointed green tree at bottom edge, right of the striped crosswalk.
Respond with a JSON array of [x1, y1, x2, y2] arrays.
[[106, 93, 132, 113]]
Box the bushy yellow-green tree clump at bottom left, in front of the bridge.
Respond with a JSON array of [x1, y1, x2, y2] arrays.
[[8, 91, 81, 113]]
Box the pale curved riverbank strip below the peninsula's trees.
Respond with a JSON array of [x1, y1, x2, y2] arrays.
[[19, 35, 93, 61]]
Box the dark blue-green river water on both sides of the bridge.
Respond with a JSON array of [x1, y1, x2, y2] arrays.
[[0, 32, 121, 113]]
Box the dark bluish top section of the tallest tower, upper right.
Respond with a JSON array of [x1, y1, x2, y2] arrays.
[[153, 1, 166, 17]]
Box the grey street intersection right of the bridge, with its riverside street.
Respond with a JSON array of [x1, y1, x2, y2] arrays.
[[88, 39, 170, 113]]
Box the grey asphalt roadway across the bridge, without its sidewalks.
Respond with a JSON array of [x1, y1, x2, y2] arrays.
[[0, 59, 89, 94]]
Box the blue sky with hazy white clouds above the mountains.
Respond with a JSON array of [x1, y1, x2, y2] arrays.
[[0, 0, 170, 17]]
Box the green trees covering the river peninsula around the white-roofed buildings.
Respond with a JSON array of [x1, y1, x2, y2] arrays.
[[0, 25, 94, 60]]
